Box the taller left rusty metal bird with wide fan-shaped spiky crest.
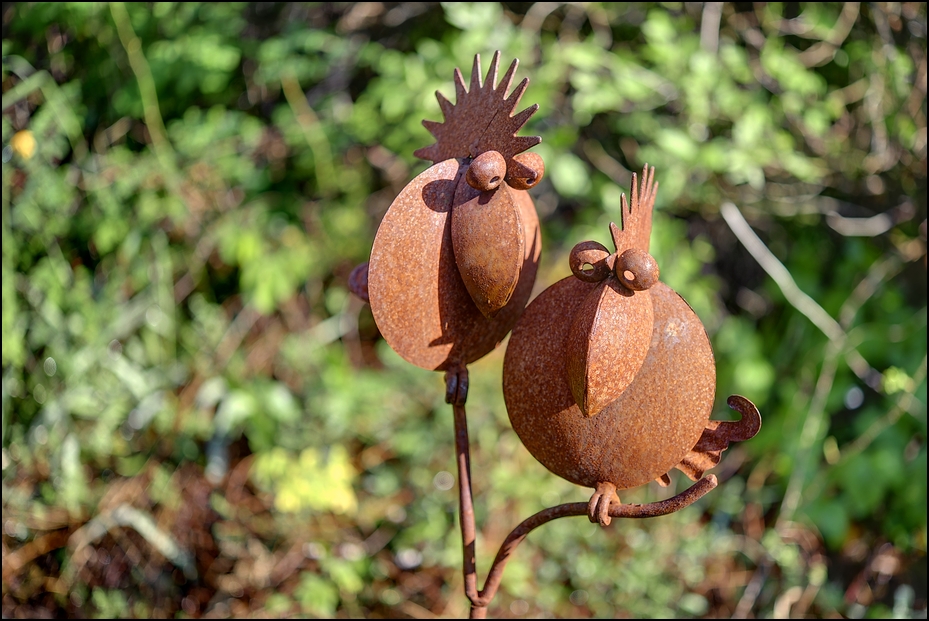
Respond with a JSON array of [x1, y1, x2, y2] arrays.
[[362, 52, 544, 370]]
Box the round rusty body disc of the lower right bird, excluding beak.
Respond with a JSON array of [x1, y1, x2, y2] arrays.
[[503, 276, 716, 489]]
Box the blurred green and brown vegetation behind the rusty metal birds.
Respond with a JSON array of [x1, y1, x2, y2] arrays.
[[2, 2, 927, 618]]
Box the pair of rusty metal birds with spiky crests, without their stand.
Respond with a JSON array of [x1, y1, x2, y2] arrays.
[[350, 52, 761, 526]]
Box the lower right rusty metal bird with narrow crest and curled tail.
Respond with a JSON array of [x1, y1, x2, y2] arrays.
[[503, 167, 760, 494]]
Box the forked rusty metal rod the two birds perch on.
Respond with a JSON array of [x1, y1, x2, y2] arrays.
[[453, 390, 717, 619]]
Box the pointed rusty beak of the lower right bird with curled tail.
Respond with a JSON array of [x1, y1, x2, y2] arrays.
[[565, 278, 652, 416]]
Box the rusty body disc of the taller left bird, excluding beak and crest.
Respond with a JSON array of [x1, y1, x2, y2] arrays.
[[368, 159, 541, 370]]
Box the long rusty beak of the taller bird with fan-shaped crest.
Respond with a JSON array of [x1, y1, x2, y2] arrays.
[[452, 162, 526, 318]]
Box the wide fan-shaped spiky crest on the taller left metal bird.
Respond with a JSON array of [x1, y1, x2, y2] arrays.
[[414, 52, 542, 171]]
